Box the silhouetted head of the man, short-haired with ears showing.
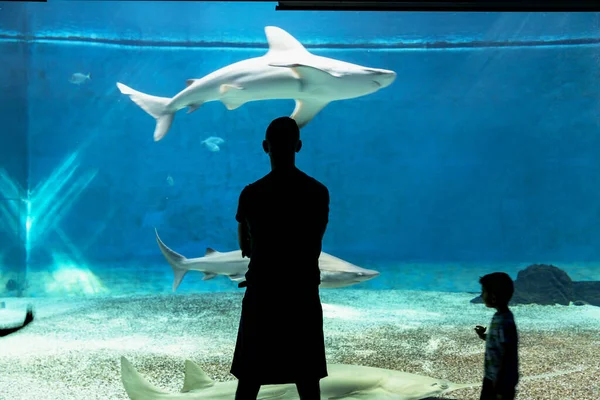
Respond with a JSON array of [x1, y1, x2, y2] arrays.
[[263, 117, 302, 160]]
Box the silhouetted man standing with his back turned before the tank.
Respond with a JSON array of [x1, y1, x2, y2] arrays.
[[231, 117, 329, 400]]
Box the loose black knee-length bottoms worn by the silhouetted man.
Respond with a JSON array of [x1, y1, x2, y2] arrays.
[[231, 286, 327, 385]]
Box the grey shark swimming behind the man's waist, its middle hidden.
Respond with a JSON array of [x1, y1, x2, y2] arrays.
[[154, 229, 379, 291]]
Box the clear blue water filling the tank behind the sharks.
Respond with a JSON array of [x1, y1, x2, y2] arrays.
[[0, 2, 600, 296]]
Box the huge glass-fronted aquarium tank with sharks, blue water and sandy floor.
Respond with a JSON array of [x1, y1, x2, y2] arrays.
[[0, 1, 600, 400]]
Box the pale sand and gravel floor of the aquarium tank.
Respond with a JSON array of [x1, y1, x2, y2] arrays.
[[0, 290, 600, 400]]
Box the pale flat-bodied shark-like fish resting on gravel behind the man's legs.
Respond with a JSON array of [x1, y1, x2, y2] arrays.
[[121, 357, 481, 400]]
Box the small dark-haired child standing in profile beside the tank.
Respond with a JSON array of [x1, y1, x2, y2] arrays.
[[475, 272, 519, 400]]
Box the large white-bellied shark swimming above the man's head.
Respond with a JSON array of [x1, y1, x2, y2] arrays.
[[117, 26, 396, 141]]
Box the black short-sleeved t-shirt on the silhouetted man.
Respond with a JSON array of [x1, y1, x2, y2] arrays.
[[236, 169, 329, 288]]
